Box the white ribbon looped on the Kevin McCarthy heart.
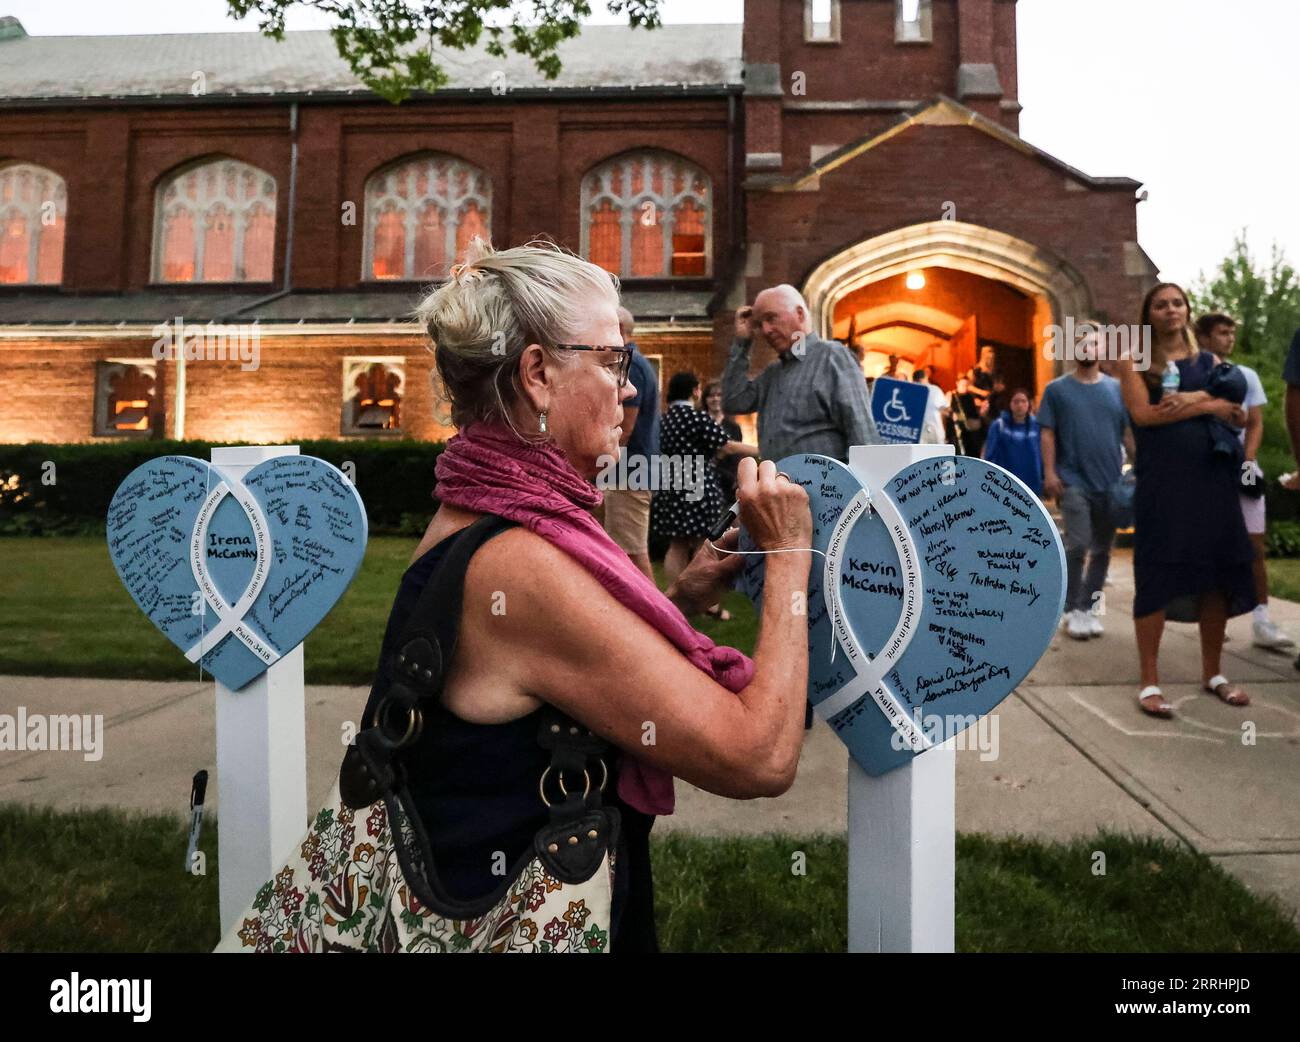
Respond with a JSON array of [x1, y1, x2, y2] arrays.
[[813, 489, 933, 752]]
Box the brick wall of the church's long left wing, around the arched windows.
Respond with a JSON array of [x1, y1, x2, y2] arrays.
[[0, 89, 733, 442]]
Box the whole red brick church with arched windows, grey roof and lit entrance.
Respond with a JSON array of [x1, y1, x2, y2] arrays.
[[0, 0, 1154, 442]]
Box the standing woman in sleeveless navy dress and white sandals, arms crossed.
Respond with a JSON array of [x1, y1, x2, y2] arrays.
[[1121, 282, 1255, 717]]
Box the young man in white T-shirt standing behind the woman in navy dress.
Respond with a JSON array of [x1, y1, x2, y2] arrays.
[[1196, 314, 1296, 651]]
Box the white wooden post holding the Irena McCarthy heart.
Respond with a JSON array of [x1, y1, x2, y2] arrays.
[[212, 446, 307, 935]]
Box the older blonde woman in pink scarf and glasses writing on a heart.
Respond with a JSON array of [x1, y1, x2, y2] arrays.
[[379, 240, 811, 952]]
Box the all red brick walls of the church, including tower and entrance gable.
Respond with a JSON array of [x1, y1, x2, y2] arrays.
[[0, 0, 1143, 440]]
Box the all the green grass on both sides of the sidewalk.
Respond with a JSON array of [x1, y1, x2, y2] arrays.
[[0, 537, 1300, 952]]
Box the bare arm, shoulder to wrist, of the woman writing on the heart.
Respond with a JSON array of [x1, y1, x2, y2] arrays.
[[463, 529, 810, 799]]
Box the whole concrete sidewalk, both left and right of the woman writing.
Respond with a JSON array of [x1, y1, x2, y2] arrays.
[[0, 543, 1300, 922]]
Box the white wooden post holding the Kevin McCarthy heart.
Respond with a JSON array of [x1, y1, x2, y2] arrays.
[[849, 444, 957, 952]]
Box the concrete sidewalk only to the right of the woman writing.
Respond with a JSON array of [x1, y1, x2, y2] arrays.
[[665, 551, 1300, 925]]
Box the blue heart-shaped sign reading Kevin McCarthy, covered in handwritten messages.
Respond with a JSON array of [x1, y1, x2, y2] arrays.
[[740, 455, 1065, 774]]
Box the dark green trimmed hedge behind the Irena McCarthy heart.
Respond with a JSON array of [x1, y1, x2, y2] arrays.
[[0, 439, 443, 535]]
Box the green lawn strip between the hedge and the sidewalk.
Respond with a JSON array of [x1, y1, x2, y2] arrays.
[[0, 537, 757, 685]]
